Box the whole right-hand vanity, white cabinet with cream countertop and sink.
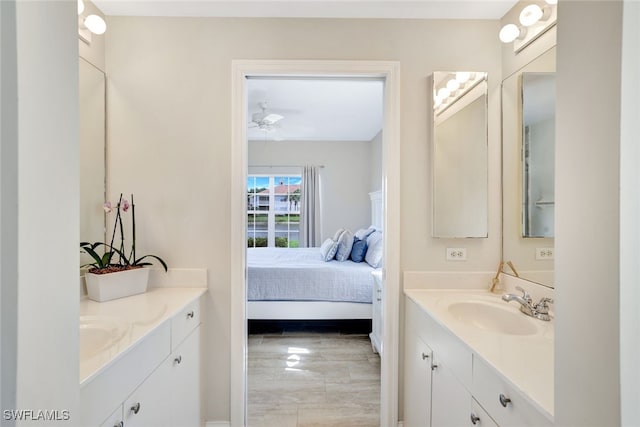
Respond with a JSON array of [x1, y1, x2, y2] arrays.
[[404, 290, 554, 427]]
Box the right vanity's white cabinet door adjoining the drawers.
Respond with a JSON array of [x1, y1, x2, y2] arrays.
[[431, 355, 471, 427]]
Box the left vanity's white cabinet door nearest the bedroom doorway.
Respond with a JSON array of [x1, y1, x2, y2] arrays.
[[169, 326, 201, 427]]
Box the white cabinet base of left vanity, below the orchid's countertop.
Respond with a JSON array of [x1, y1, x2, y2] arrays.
[[79, 290, 202, 427]]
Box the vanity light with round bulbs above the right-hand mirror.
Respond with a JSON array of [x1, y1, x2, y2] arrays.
[[498, 0, 558, 53]]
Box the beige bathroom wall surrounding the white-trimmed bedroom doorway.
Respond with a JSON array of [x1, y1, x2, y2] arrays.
[[106, 17, 502, 420]]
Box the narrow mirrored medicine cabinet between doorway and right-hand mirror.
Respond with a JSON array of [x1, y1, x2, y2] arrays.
[[432, 71, 488, 238]]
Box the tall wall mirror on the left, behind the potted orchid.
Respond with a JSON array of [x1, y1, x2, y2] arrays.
[[78, 58, 106, 265]]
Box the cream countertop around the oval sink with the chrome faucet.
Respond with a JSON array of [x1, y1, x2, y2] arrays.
[[405, 289, 554, 421]]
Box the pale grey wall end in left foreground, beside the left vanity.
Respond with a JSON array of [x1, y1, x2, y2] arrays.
[[10, 1, 79, 425]]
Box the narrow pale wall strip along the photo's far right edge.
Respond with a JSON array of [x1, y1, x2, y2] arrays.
[[620, 1, 640, 426]]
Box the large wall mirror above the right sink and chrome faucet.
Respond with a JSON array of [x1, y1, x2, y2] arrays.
[[502, 48, 556, 286]]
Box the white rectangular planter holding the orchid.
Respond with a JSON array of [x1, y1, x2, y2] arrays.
[[85, 268, 149, 302]]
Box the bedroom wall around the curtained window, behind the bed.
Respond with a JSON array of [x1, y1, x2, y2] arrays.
[[248, 141, 372, 243]]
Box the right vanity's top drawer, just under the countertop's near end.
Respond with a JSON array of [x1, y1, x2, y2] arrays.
[[472, 357, 553, 427]]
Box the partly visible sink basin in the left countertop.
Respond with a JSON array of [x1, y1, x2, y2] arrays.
[[80, 316, 129, 360]]
